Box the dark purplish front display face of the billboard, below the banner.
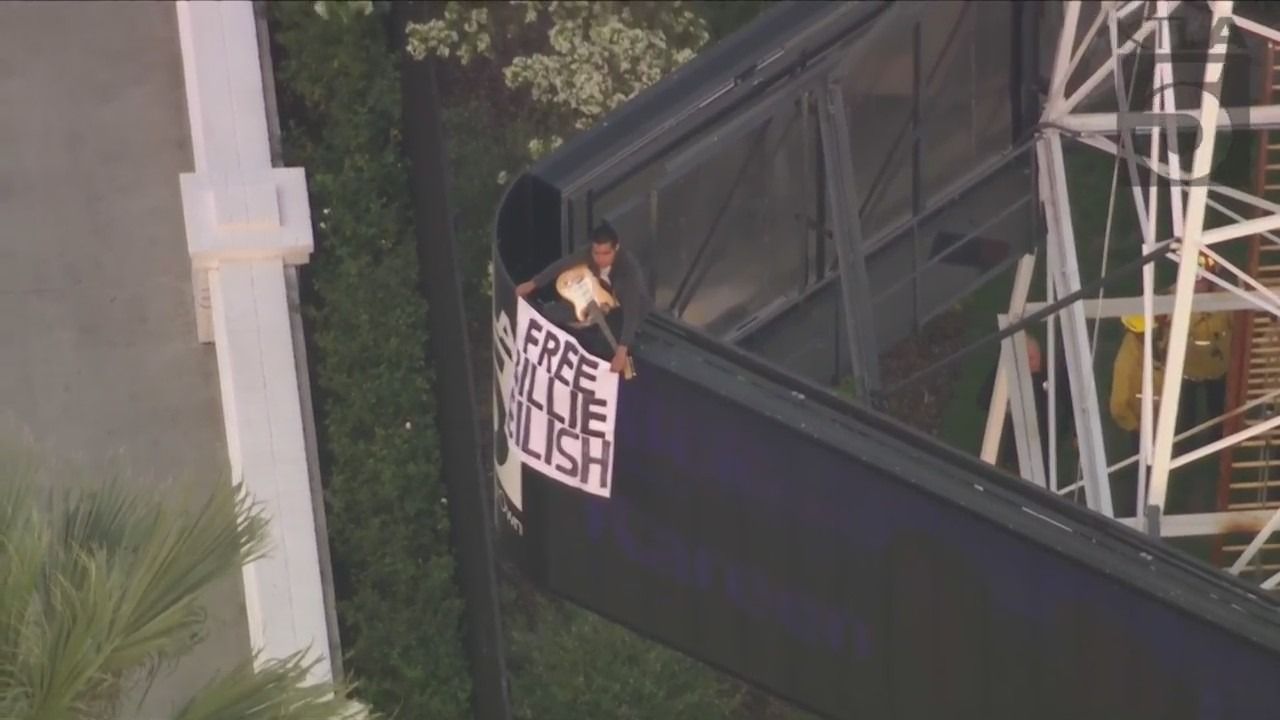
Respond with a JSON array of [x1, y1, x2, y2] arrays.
[[494, 254, 1280, 720]]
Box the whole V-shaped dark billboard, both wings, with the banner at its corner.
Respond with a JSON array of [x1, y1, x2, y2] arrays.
[[483, 3, 1280, 720]]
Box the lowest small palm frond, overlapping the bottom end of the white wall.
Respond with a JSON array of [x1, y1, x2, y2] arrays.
[[174, 652, 378, 720]]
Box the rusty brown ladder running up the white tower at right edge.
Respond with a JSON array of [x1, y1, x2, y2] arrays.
[[1216, 41, 1280, 580]]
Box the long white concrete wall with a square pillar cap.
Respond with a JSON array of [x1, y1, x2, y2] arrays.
[[177, 1, 334, 680]]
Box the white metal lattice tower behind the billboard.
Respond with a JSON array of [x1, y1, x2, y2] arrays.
[[983, 0, 1280, 589]]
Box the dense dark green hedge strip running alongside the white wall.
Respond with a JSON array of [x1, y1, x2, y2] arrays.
[[270, 3, 471, 720]]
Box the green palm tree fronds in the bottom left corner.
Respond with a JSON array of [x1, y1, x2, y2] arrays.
[[0, 450, 369, 720]]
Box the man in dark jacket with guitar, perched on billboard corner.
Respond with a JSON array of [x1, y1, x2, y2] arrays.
[[516, 223, 653, 373]]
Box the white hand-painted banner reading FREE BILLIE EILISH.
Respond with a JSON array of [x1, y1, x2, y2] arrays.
[[498, 299, 620, 497]]
